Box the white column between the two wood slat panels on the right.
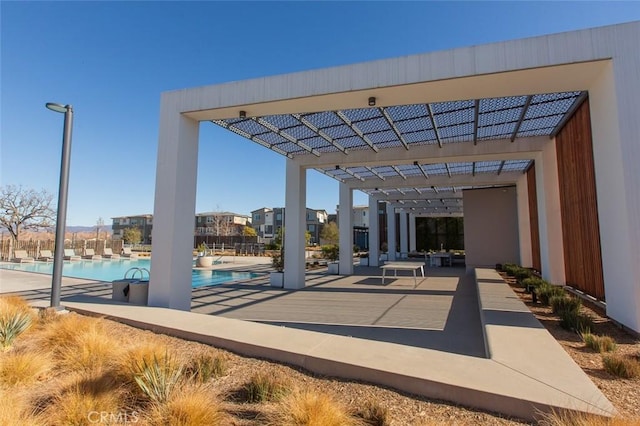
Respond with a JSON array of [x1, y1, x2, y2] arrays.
[[535, 139, 565, 284]]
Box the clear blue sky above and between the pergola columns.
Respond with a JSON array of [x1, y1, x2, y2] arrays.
[[0, 1, 640, 226]]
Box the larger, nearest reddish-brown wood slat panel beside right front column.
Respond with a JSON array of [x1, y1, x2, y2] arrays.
[[556, 100, 605, 300]]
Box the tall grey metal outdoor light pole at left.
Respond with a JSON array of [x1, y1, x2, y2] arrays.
[[46, 102, 73, 309]]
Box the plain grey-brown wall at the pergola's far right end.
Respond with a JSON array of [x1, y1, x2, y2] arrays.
[[462, 187, 520, 268]]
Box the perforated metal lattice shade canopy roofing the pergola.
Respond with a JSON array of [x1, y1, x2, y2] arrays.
[[212, 91, 586, 211]]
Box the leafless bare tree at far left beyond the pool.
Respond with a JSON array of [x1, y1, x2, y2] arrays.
[[0, 185, 55, 241]]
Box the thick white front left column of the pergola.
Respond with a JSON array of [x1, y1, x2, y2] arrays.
[[148, 102, 199, 311]]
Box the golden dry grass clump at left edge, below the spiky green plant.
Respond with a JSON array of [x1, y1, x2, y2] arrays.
[[0, 352, 52, 386]]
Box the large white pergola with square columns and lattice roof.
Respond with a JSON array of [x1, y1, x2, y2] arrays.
[[149, 23, 640, 331]]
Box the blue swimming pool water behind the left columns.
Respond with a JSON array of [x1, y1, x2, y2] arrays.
[[0, 259, 260, 288]]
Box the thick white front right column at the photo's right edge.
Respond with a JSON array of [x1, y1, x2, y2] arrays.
[[589, 57, 640, 333]]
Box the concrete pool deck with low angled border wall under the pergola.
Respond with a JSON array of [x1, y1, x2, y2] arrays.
[[0, 263, 615, 420]]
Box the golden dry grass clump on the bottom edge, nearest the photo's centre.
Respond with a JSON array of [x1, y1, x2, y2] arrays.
[[267, 391, 362, 426]]
